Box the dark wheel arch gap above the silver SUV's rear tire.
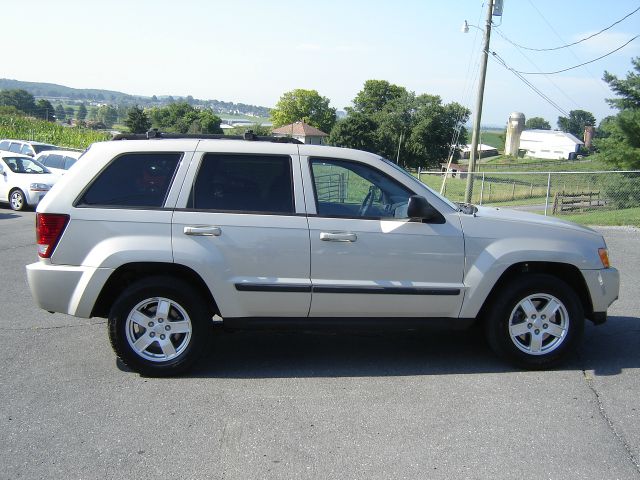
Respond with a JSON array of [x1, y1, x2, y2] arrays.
[[91, 262, 220, 318]]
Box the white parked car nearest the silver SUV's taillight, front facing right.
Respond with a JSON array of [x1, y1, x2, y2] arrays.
[[0, 151, 59, 210]]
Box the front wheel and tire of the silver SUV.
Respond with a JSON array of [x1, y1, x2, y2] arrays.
[[484, 274, 584, 370]]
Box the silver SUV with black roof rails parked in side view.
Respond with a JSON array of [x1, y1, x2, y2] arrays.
[[27, 133, 619, 376]]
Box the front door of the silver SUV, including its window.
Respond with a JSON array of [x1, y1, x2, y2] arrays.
[[308, 158, 464, 317]]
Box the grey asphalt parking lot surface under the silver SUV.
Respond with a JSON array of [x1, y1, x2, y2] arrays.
[[0, 207, 640, 479]]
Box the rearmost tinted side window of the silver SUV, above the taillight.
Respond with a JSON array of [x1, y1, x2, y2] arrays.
[[76, 153, 182, 208]]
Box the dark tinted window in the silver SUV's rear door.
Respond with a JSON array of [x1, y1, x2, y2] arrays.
[[189, 154, 294, 213]]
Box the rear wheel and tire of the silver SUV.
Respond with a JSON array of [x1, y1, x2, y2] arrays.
[[108, 276, 213, 377]]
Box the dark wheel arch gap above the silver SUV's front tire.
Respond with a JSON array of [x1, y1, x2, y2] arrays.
[[478, 262, 593, 320]]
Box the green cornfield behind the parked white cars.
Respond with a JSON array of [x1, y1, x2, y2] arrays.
[[0, 115, 111, 149]]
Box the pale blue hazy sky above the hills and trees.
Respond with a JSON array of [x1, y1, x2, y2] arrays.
[[5, 0, 640, 128]]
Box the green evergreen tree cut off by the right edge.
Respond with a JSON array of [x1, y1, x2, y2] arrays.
[[594, 57, 640, 169]]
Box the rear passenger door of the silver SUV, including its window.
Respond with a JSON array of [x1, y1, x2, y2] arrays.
[[172, 140, 311, 318]]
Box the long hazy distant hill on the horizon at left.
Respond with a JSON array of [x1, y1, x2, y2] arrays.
[[0, 78, 270, 117]]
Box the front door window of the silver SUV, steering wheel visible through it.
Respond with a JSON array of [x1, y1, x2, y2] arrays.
[[311, 158, 413, 218]]
